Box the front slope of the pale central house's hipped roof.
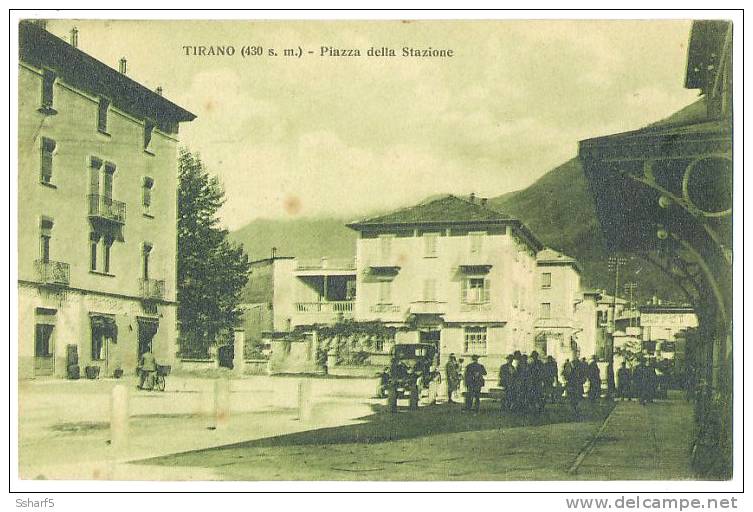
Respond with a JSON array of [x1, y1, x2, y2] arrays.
[[348, 194, 514, 227]]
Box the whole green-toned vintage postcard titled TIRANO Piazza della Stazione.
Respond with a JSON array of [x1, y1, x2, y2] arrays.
[[9, 11, 743, 496]]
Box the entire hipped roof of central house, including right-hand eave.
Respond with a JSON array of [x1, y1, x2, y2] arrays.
[[347, 194, 544, 251]]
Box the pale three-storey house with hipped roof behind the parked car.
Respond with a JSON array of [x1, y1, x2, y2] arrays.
[[348, 195, 542, 373]]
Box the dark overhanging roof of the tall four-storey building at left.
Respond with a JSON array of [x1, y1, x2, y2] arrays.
[[18, 21, 196, 127]]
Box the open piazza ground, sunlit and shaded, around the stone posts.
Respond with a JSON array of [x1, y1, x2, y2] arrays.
[[19, 377, 692, 480]]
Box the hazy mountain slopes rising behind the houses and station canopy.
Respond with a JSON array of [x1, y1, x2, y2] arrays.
[[231, 99, 706, 301]]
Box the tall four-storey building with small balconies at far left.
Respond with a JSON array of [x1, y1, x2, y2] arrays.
[[18, 22, 195, 377]]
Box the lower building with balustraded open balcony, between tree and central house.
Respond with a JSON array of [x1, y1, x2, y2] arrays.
[[240, 255, 356, 350]]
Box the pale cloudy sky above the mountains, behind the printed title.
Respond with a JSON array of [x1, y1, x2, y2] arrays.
[[48, 20, 698, 229]]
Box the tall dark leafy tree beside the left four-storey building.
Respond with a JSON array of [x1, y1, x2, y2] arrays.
[[178, 149, 250, 355]]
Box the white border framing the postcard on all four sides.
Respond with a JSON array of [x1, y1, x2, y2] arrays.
[[2, 5, 744, 504]]
